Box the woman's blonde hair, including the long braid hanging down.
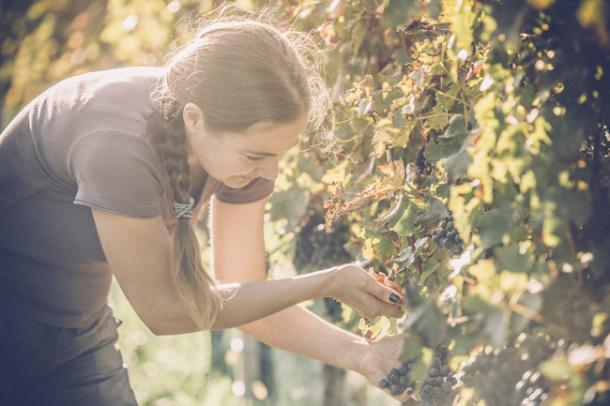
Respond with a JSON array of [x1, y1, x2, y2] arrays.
[[148, 12, 334, 329]]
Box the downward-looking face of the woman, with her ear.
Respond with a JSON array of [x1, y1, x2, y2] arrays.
[[184, 103, 307, 188]]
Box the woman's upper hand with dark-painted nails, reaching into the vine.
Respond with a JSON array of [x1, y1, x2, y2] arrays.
[[325, 264, 404, 319]]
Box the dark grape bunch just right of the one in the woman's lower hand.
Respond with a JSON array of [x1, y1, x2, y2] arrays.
[[419, 346, 457, 406]]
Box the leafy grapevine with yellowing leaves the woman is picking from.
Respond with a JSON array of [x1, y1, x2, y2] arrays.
[[282, 0, 610, 406]]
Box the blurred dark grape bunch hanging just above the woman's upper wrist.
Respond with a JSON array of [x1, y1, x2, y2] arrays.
[[294, 209, 352, 270]]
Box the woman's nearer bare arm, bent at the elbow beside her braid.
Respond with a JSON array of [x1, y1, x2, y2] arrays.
[[93, 209, 396, 334]]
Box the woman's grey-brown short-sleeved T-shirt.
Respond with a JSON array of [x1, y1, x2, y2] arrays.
[[0, 68, 273, 328]]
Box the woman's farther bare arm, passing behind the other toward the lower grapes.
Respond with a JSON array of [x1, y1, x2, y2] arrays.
[[210, 199, 401, 372]]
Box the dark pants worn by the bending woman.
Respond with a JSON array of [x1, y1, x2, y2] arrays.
[[0, 308, 137, 406]]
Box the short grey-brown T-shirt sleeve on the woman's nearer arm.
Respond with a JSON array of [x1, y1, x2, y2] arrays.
[[68, 131, 163, 217]]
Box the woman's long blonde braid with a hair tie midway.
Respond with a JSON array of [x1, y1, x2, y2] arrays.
[[148, 113, 221, 329]]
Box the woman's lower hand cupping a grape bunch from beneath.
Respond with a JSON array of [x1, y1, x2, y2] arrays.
[[356, 334, 409, 401]]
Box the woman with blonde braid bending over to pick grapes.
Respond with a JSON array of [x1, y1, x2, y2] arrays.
[[0, 16, 403, 405]]
